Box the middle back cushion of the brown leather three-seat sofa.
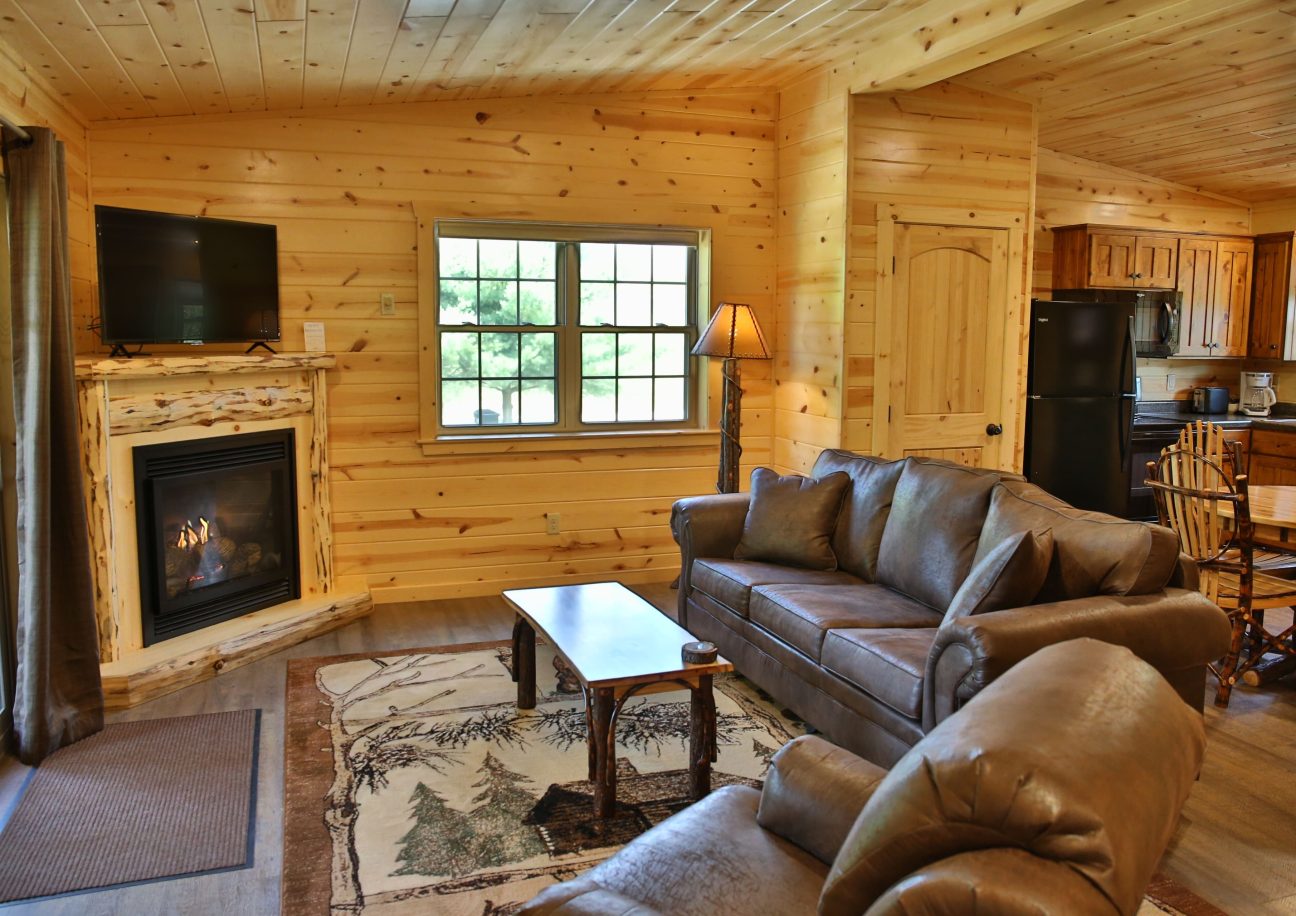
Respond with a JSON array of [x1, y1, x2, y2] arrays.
[[877, 460, 998, 613]]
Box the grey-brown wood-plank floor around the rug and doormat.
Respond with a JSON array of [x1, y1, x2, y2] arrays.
[[0, 584, 1296, 916]]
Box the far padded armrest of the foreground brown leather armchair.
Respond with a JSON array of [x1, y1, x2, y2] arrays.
[[756, 735, 886, 865]]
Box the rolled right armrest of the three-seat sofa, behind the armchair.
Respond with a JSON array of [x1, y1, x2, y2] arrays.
[[923, 588, 1230, 731]]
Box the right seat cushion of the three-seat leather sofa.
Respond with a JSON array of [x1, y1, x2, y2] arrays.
[[822, 627, 936, 719]]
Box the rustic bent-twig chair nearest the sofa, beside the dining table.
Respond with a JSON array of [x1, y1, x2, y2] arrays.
[[1147, 446, 1296, 707]]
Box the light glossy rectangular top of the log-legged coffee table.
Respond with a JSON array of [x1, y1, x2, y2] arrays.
[[504, 582, 734, 687]]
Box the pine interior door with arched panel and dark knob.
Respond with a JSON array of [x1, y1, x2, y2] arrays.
[[875, 223, 1021, 468]]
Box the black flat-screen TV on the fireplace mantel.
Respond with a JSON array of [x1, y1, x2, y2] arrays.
[[95, 206, 279, 343]]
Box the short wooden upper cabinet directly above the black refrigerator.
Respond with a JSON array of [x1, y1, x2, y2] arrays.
[[1052, 224, 1179, 289]]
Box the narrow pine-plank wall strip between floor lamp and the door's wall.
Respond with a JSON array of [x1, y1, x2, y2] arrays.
[[774, 69, 850, 473]]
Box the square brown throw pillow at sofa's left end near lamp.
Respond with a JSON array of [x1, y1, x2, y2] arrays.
[[734, 468, 850, 569]]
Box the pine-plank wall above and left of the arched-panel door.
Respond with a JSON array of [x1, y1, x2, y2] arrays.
[[842, 83, 1036, 468]]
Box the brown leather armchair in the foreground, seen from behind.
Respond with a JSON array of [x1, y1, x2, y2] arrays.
[[521, 640, 1205, 916]]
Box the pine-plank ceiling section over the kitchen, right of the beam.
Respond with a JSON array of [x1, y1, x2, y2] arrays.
[[960, 0, 1296, 201]]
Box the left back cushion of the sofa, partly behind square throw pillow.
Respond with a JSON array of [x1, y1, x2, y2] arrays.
[[810, 448, 905, 582]]
